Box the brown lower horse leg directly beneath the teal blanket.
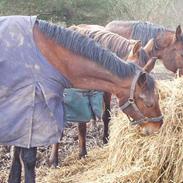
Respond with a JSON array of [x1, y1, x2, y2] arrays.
[[78, 123, 87, 158]]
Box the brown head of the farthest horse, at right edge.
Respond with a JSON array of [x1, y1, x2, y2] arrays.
[[144, 25, 183, 75]]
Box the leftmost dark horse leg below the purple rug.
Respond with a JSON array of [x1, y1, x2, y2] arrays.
[[8, 147, 22, 183]]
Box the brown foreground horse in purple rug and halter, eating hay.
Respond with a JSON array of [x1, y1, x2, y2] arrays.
[[0, 16, 163, 183]]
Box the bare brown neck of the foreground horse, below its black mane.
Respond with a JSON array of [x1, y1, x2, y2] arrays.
[[34, 28, 132, 94]]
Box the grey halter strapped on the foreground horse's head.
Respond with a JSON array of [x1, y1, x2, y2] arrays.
[[120, 71, 163, 125]]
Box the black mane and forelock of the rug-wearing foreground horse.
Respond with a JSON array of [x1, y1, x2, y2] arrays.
[[37, 20, 155, 91]]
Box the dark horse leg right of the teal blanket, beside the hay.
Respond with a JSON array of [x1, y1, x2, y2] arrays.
[[102, 93, 111, 144]]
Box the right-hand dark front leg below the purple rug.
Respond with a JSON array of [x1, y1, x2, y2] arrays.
[[21, 147, 37, 183]]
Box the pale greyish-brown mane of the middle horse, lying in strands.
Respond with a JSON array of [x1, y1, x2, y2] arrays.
[[69, 26, 135, 59]]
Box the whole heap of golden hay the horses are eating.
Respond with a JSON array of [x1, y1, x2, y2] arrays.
[[43, 79, 183, 183]]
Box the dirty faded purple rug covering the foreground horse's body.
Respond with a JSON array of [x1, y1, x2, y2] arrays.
[[0, 16, 70, 148]]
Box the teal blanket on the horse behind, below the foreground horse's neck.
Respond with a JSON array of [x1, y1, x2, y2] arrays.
[[64, 88, 103, 123]]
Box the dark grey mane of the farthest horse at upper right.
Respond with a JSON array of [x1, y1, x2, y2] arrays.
[[131, 21, 168, 46]]
